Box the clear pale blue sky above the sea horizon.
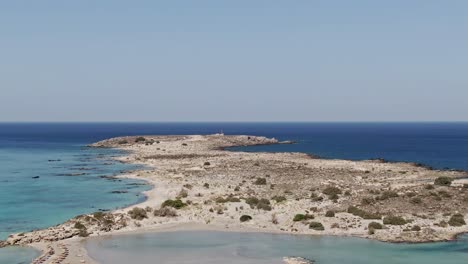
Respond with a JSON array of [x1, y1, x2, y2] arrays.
[[0, 0, 468, 121]]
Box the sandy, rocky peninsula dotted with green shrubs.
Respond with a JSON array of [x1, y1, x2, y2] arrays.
[[0, 134, 468, 263]]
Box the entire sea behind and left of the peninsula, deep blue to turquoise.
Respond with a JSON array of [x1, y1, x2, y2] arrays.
[[0, 123, 468, 263]]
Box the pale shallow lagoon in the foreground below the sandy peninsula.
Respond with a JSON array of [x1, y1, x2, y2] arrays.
[[86, 231, 468, 264]]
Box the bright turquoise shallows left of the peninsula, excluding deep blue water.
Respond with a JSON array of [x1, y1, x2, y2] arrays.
[[0, 143, 149, 239]]
